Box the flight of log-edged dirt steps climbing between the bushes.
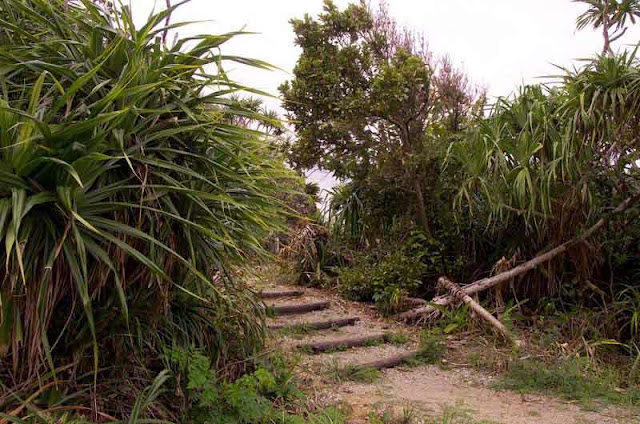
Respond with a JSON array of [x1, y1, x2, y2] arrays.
[[259, 288, 418, 369]]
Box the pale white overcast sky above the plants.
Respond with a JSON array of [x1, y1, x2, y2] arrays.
[[130, 0, 640, 190]]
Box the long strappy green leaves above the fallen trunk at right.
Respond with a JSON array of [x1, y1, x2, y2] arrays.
[[454, 53, 640, 240]]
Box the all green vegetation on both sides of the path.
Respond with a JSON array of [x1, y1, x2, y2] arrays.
[[0, 0, 640, 424]]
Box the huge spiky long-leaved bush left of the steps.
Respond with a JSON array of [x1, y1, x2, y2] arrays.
[[0, 0, 290, 417]]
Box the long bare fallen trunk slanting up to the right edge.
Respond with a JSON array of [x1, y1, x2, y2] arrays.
[[397, 193, 640, 321]]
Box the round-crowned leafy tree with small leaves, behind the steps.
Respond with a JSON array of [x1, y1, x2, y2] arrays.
[[280, 0, 476, 234]]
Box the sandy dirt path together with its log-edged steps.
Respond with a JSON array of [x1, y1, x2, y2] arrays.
[[254, 280, 637, 424]]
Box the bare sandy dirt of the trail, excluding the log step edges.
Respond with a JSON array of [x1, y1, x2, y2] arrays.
[[256, 272, 640, 424]]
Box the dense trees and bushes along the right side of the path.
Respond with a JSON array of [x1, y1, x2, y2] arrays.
[[281, 0, 640, 386]]
